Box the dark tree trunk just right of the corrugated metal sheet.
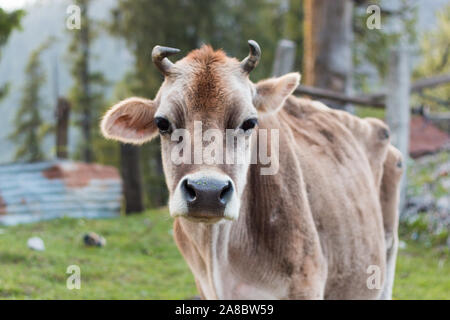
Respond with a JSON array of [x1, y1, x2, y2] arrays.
[[120, 144, 144, 214]]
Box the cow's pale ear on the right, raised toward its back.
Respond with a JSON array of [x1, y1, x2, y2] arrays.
[[253, 72, 300, 112]]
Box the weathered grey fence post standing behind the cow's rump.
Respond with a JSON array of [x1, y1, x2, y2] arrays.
[[386, 43, 410, 212]]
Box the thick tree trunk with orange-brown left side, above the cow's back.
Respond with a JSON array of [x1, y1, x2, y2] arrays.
[[302, 0, 353, 109]]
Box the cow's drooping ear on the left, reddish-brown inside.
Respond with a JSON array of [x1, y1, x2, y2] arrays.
[[100, 97, 158, 144]]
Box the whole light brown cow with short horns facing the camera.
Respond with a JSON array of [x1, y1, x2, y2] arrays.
[[100, 40, 402, 299]]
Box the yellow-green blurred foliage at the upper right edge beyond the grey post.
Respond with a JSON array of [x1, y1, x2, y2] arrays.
[[413, 4, 450, 111]]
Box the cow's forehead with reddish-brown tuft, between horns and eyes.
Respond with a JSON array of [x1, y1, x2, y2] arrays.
[[157, 46, 252, 122]]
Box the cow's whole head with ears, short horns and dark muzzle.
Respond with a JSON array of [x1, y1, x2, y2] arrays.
[[101, 42, 300, 223]]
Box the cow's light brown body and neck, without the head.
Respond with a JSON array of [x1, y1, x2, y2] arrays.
[[174, 97, 401, 299]]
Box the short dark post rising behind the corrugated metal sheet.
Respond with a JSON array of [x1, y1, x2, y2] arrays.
[[56, 98, 70, 159]]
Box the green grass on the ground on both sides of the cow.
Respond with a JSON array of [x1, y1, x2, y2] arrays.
[[0, 209, 450, 299]]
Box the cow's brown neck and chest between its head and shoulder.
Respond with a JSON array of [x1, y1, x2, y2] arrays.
[[176, 116, 320, 295]]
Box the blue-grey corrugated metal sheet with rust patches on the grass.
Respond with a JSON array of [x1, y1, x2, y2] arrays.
[[0, 160, 122, 225]]
